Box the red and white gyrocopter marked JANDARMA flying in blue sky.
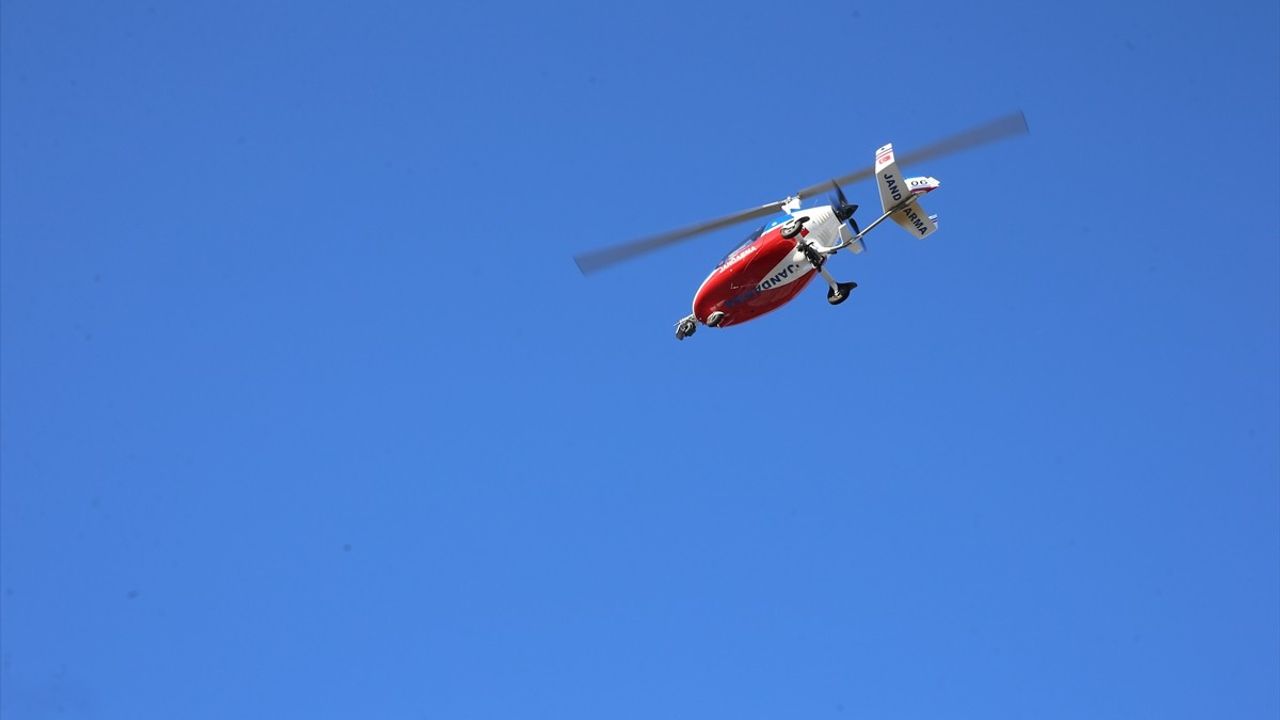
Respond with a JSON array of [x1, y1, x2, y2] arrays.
[[575, 111, 1027, 340]]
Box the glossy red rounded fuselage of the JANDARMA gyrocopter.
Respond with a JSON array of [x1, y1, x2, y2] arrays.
[[694, 224, 814, 328]]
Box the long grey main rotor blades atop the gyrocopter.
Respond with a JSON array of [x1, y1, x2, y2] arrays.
[[573, 110, 1027, 274]]
